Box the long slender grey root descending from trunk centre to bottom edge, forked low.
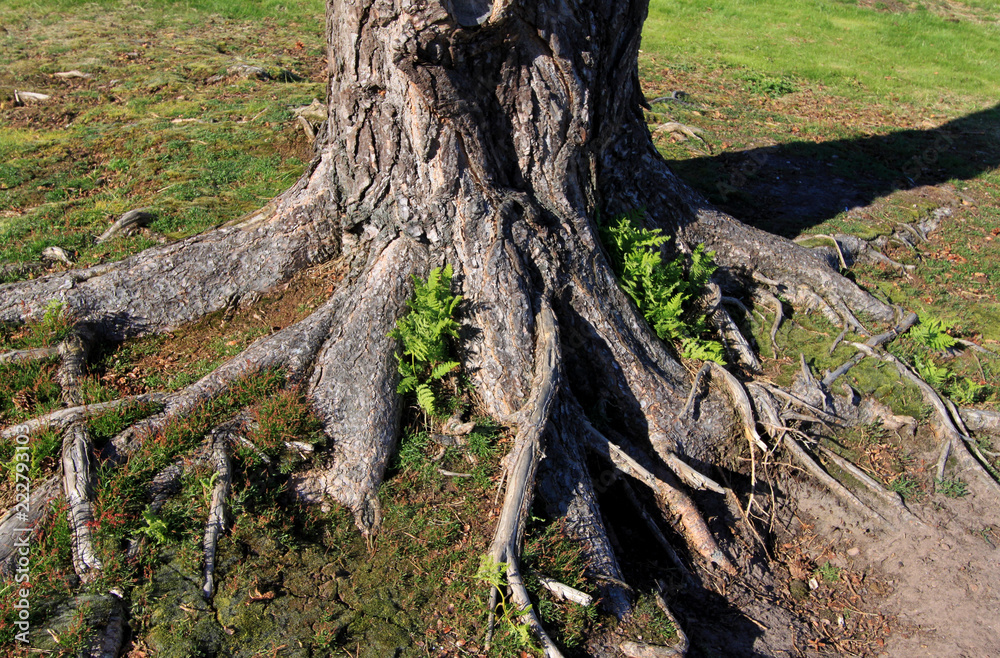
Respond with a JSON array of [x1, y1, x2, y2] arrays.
[[487, 300, 562, 658]]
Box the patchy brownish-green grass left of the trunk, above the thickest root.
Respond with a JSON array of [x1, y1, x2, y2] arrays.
[[0, 2, 324, 278]]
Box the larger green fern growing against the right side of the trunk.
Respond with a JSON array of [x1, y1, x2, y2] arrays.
[[599, 213, 725, 364]]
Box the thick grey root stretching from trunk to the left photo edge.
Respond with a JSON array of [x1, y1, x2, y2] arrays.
[[0, 182, 340, 340]]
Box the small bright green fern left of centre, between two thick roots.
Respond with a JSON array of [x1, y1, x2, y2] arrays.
[[389, 265, 462, 416]]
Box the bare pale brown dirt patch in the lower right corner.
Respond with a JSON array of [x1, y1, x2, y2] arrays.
[[795, 468, 1000, 658]]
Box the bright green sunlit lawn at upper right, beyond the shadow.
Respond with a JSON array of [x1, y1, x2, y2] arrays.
[[642, 0, 1000, 105]]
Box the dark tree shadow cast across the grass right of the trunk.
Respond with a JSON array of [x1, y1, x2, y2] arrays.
[[669, 104, 1000, 237]]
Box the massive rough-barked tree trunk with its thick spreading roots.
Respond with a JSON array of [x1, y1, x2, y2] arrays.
[[0, 0, 988, 655]]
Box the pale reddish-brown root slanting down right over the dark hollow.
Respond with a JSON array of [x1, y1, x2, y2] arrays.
[[580, 418, 736, 573]]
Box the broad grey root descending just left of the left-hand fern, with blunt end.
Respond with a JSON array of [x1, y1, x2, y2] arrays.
[[293, 237, 427, 535]]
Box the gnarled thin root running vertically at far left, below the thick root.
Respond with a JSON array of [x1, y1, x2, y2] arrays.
[[58, 332, 102, 582]]
